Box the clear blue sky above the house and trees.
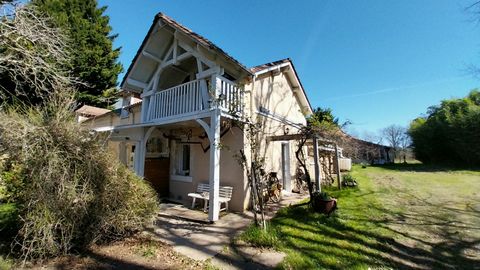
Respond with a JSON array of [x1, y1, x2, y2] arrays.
[[99, 0, 480, 136]]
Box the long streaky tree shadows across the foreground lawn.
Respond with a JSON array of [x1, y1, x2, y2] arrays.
[[273, 204, 480, 269]]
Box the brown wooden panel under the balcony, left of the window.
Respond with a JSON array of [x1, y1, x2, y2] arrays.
[[145, 157, 170, 197]]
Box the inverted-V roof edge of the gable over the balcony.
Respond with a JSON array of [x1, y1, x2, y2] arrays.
[[120, 12, 251, 87]]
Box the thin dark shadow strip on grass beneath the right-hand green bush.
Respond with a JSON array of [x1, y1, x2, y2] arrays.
[[370, 163, 480, 172]]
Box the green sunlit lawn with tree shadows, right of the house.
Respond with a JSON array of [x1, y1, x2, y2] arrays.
[[242, 164, 480, 269]]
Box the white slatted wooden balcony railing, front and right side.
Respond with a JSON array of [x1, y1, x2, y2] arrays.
[[143, 77, 244, 122]]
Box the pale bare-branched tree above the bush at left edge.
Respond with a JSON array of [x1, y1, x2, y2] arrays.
[[0, 5, 73, 103]]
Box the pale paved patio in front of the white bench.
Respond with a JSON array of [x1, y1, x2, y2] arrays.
[[144, 193, 308, 269]]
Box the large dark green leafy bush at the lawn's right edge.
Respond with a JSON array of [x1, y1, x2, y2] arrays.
[[408, 90, 480, 166]]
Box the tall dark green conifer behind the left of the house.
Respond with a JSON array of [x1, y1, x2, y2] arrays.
[[31, 0, 123, 107]]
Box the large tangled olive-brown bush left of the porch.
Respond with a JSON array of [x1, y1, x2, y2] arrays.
[[0, 99, 158, 259]]
